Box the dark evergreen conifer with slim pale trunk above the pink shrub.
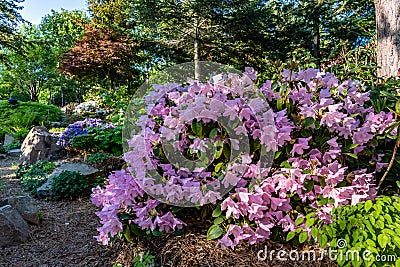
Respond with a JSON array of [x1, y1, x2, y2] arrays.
[[134, 0, 276, 76]]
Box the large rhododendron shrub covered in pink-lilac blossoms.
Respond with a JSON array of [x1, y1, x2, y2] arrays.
[[92, 69, 396, 248]]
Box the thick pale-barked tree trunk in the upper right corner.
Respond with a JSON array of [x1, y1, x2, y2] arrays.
[[375, 0, 400, 78]]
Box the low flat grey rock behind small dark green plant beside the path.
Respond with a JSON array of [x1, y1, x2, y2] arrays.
[[36, 163, 101, 197]]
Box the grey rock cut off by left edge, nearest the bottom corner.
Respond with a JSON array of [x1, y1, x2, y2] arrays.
[[0, 205, 30, 247]]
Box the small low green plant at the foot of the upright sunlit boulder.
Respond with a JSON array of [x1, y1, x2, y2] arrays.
[[16, 161, 55, 191]]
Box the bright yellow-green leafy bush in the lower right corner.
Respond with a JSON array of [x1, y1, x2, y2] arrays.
[[316, 196, 400, 266]]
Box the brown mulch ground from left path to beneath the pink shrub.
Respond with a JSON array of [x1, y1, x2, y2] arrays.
[[0, 158, 337, 267]]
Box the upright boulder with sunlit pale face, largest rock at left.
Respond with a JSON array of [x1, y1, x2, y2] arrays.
[[21, 126, 65, 164]]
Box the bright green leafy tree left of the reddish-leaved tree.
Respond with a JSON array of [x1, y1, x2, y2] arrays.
[[0, 10, 88, 105]]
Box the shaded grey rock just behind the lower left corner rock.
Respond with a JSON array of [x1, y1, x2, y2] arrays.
[[6, 196, 39, 225]]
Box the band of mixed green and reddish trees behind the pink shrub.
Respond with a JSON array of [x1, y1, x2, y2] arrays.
[[0, 0, 376, 105]]
